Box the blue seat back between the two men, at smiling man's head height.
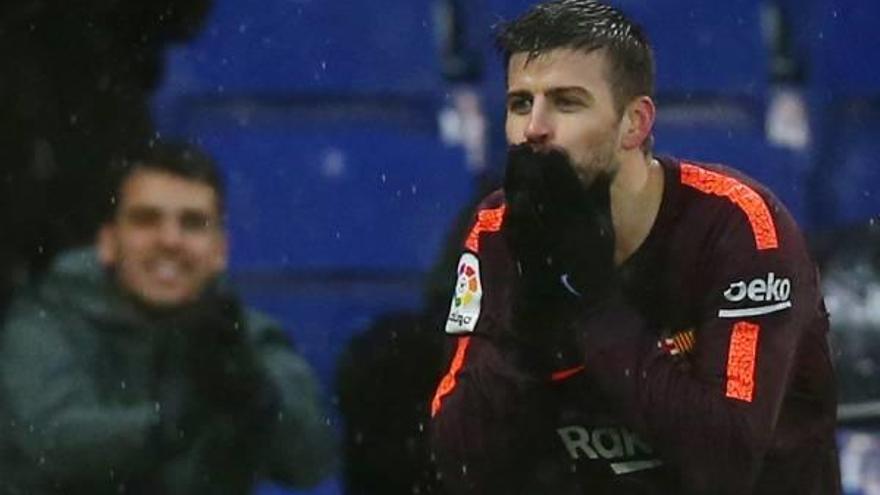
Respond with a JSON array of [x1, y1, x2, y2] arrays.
[[185, 114, 473, 273]]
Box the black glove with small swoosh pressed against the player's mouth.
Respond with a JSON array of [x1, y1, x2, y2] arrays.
[[503, 145, 616, 304]]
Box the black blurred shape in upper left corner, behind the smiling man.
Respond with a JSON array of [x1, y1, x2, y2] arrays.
[[0, 0, 212, 310]]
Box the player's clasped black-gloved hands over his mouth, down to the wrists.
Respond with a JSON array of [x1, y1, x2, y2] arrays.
[[502, 145, 616, 376]]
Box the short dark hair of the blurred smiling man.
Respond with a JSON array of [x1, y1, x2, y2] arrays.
[[106, 140, 226, 220]]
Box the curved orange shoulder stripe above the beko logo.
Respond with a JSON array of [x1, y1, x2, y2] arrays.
[[681, 163, 779, 251]]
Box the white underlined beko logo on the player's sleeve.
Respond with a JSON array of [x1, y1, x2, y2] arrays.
[[718, 272, 791, 318]]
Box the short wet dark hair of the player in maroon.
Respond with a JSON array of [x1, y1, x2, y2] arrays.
[[496, 0, 654, 114]]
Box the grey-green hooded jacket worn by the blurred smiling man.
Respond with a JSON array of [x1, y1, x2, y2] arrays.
[[0, 250, 336, 494]]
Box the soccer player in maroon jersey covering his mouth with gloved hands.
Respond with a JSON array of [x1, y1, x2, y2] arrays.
[[431, 0, 840, 494]]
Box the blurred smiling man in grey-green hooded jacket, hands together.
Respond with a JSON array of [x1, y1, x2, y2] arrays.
[[0, 144, 335, 494]]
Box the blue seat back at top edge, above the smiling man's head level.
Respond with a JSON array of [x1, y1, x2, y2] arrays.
[[153, 0, 442, 96]]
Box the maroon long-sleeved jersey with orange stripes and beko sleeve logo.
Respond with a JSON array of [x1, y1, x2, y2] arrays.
[[431, 158, 840, 495]]
